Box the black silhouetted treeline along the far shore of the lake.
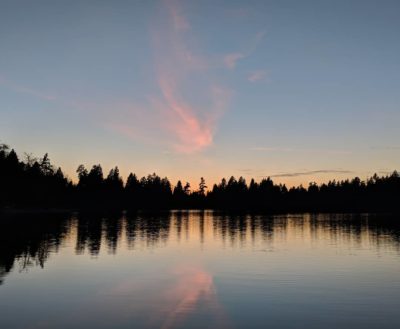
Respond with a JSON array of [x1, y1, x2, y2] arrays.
[[0, 144, 400, 212]]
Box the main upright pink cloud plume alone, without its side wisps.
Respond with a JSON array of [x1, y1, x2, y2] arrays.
[[153, 0, 229, 153]]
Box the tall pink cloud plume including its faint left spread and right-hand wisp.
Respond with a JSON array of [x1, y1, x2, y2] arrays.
[[67, 0, 265, 154]]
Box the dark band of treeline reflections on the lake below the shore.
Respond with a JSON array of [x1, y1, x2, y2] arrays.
[[0, 211, 400, 284]]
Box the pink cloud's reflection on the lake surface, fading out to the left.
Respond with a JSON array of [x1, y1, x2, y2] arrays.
[[95, 265, 231, 329]]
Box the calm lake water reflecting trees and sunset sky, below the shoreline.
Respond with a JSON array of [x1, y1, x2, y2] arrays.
[[0, 211, 400, 329]]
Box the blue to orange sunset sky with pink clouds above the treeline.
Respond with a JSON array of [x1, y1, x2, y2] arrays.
[[0, 0, 400, 186]]
